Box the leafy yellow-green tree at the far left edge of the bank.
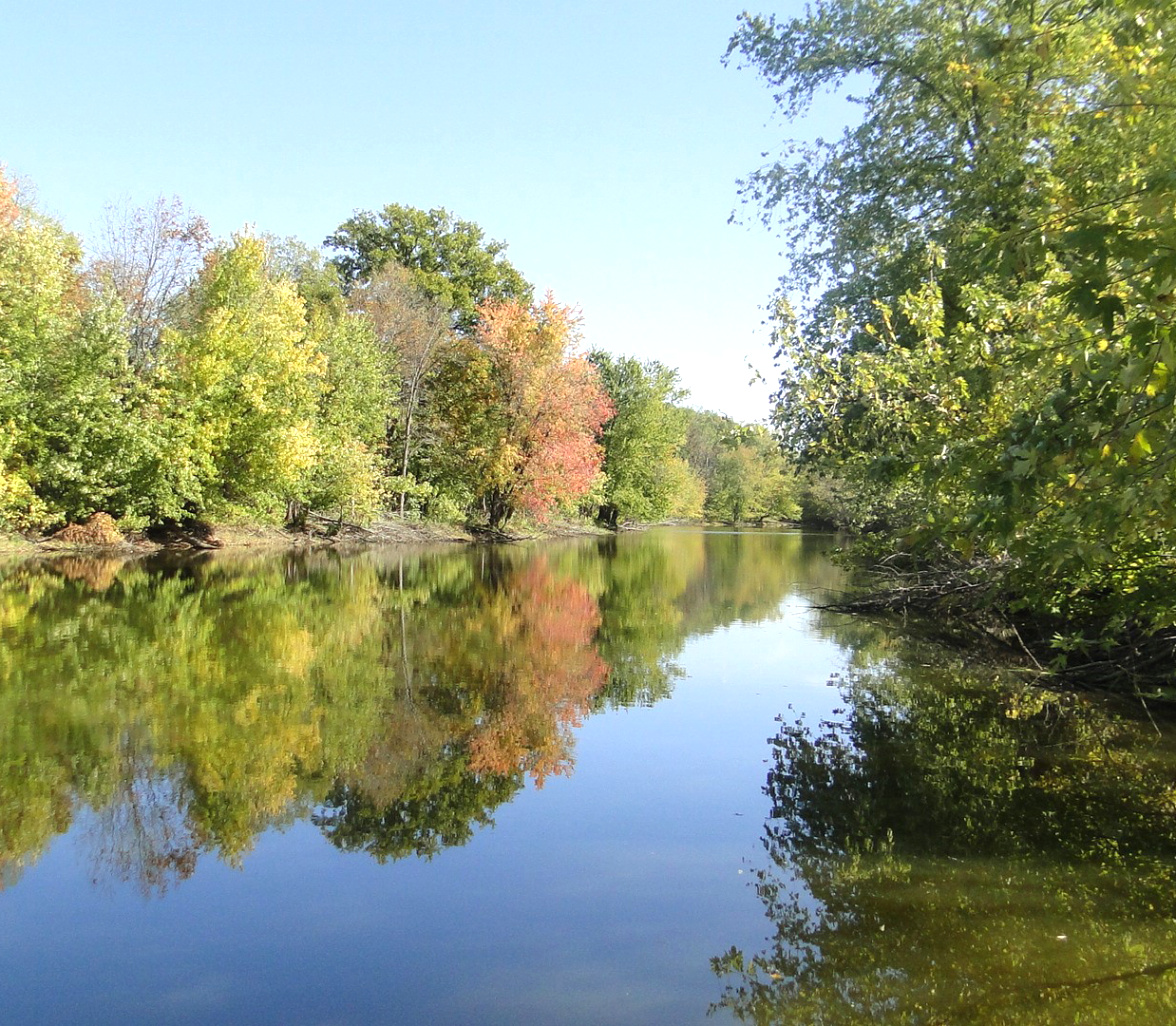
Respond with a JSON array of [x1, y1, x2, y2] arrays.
[[0, 169, 153, 527]]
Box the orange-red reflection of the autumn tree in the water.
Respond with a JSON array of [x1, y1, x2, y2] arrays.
[[469, 559, 608, 787]]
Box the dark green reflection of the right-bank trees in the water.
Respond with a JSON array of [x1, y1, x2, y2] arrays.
[[714, 648, 1176, 1024]]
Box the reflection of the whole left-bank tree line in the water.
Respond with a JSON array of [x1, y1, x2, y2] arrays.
[[0, 532, 833, 893]]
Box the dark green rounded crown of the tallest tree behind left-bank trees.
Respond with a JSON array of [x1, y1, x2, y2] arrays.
[[323, 204, 532, 334]]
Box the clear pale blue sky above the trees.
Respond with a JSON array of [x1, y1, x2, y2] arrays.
[[0, 0, 843, 420]]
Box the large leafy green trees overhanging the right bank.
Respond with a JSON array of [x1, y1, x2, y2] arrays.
[[728, 0, 1176, 684]]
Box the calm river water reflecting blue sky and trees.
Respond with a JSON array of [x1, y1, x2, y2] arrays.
[[0, 531, 1176, 1026]]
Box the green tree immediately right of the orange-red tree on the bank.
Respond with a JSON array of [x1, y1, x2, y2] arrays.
[[589, 351, 701, 527]]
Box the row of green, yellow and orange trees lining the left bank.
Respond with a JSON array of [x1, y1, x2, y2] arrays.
[[0, 174, 800, 531]]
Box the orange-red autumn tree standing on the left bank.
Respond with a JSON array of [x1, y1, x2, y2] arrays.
[[436, 294, 612, 529]]
